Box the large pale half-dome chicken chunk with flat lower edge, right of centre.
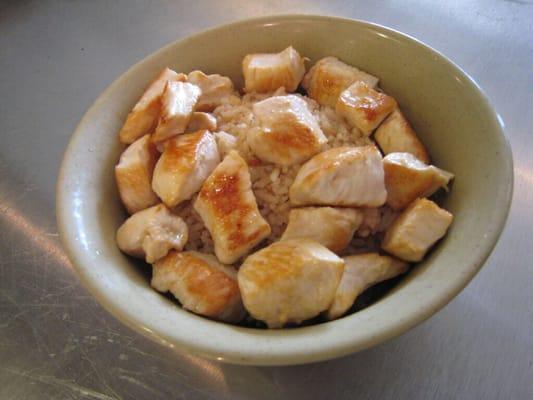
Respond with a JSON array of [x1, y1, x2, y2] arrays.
[[289, 146, 387, 207]]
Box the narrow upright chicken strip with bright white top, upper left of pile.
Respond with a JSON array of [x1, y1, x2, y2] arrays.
[[152, 82, 202, 142]]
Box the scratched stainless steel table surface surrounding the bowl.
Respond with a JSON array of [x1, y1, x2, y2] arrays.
[[0, 0, 533, 400]]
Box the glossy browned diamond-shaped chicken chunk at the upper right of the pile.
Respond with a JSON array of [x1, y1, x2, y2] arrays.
[[335, 82, 396, 135]]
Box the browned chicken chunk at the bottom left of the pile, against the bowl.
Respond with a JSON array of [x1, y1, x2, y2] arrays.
[[152, 251, 246, 322]]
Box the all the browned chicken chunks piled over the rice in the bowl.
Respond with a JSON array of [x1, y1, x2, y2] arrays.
[[115, 47, 453, 328]]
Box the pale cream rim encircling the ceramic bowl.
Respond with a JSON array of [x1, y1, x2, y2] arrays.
[[56, 14, 514, 365]]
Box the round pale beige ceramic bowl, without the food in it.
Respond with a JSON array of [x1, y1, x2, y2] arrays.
[[57, 16, 513, 364]]
